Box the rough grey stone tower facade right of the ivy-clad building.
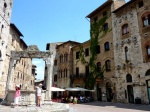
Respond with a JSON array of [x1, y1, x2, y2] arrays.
[[112, 2, 149, 103]]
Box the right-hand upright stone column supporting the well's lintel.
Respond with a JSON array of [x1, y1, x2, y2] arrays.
[[44, 58, 53, 101]]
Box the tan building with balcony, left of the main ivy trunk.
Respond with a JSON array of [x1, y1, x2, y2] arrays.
[[70, 40, 90, 96]]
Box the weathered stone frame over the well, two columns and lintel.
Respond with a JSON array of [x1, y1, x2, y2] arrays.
[[6, 45, 53, 100]]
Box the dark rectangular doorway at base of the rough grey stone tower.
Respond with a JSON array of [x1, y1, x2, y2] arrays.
[[127, 85, 134, 103]]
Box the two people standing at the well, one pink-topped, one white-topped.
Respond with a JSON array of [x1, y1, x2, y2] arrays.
[[14, 83, 42, 107]]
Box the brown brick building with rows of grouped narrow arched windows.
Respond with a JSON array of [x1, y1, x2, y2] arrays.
[[57, 40, 79, 96]]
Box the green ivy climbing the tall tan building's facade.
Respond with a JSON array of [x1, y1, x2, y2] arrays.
[[78, 16, 110, 89]]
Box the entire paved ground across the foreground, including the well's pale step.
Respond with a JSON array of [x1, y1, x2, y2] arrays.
[[0, 101, 150, 112]]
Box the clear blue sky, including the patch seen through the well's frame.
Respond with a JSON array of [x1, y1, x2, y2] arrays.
[[11, 0, 129, 79]]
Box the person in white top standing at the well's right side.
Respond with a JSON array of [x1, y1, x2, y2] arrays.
[[35, 83, 42, 107]]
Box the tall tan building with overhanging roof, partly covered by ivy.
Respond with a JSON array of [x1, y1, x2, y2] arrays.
[[84, 0, 125, 101]]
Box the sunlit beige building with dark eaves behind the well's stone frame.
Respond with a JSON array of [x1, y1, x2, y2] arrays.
[[9, 23, 34, 90]]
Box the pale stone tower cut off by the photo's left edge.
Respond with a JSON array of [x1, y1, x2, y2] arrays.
[[0, 0, 13, 97]]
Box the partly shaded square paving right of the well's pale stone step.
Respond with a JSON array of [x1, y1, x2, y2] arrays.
[[69, 101, 150, 112]]
